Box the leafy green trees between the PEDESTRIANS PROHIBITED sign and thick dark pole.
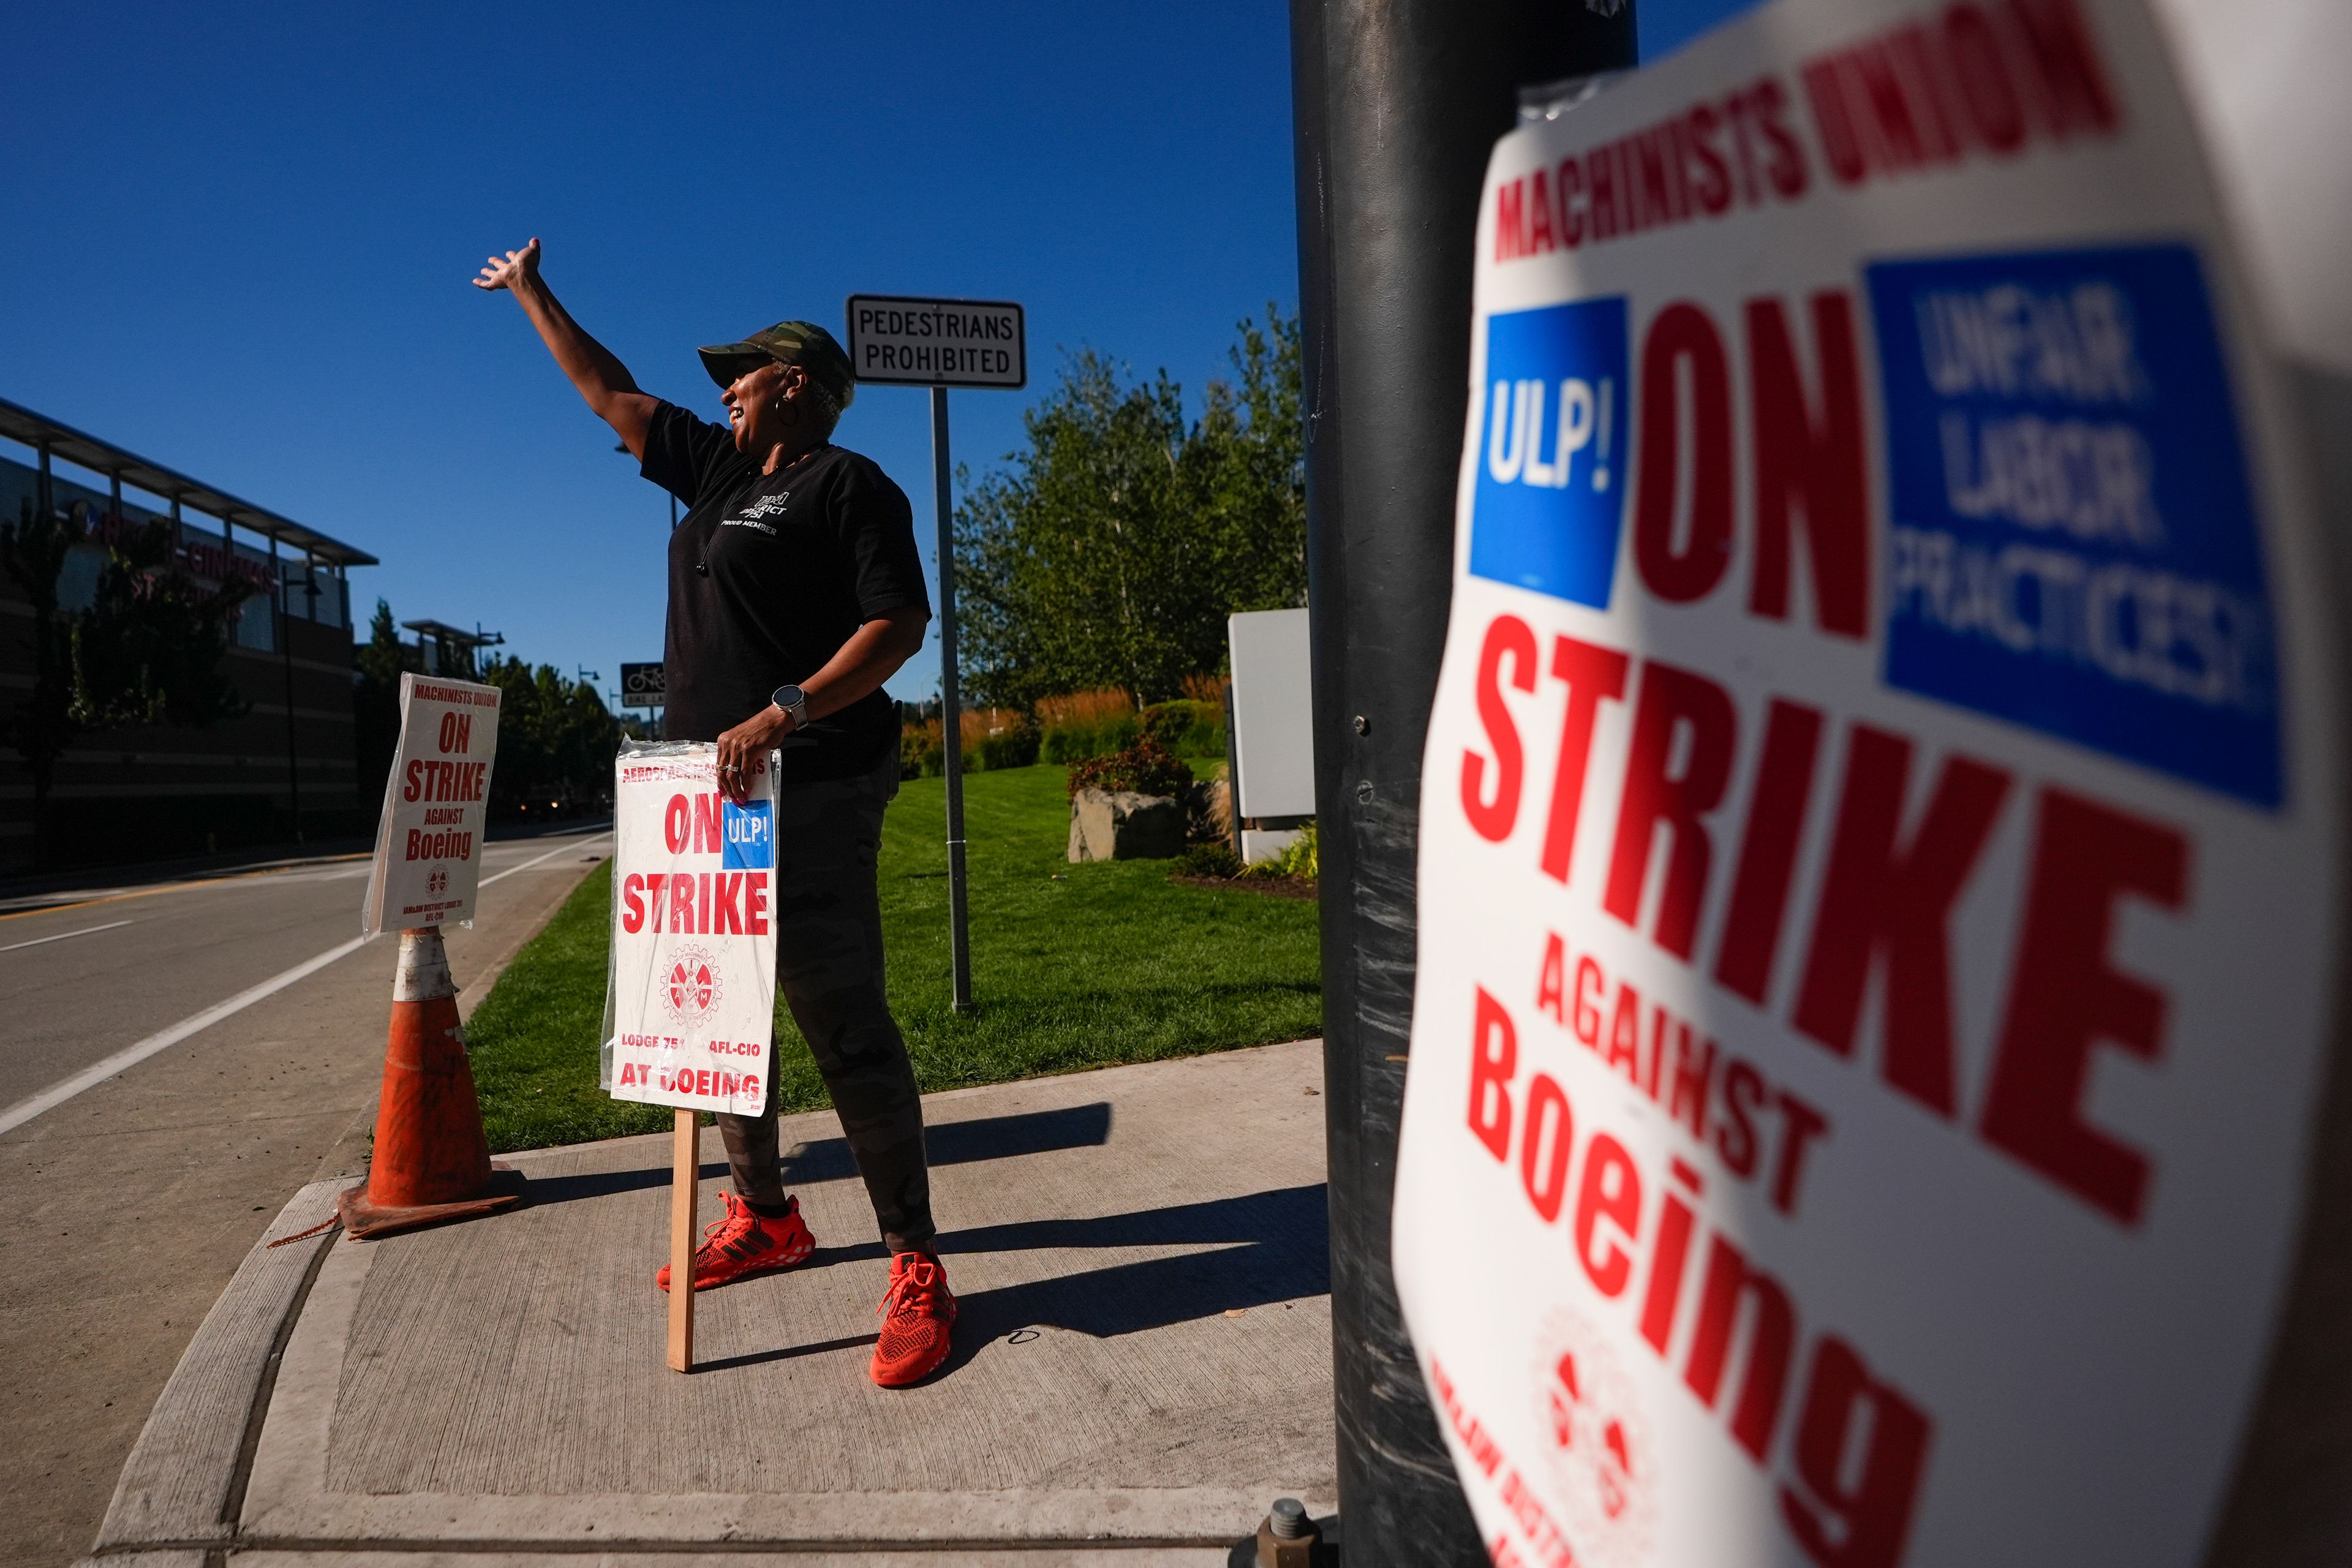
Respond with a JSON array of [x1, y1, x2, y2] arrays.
[[955, 308, 1305, 705]]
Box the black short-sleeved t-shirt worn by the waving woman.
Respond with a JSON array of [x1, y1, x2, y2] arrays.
[[639, 402, 932, 780]]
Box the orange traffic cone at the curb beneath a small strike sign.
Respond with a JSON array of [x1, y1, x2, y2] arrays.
[[336, 926, 522, 1239]]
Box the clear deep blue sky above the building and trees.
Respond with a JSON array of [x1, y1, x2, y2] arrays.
[[0, 0, 1745, 696]]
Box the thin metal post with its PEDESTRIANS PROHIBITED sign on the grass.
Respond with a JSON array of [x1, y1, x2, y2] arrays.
[[849, 294, 1028, 1013]]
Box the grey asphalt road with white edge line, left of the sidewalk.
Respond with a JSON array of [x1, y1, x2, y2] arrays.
[[0, 830, 611, 1568]]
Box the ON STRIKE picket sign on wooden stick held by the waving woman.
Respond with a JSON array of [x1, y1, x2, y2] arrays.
[[605, 741, 776, 1371]]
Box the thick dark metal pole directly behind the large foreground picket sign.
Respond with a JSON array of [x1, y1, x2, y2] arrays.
[[1291, 0, 1635, 1568]]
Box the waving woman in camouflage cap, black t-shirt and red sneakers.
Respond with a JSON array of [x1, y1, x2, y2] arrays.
[[475, 239, 955, 1387]]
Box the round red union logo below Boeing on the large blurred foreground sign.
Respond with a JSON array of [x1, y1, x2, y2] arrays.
[[1536, 1310, 1658, 1568]]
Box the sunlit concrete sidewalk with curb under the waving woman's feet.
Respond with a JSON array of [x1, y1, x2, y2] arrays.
[[83, 1041, 1333, 1568]]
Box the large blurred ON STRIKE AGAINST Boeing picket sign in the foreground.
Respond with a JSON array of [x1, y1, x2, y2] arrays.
[[1395, 0, 2343, 1568]]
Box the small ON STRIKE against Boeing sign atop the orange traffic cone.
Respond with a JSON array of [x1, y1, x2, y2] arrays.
[[360, 675, 499, 936]]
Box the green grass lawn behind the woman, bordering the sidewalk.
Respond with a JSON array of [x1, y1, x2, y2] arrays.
[[466, 766, 1322, 1150]]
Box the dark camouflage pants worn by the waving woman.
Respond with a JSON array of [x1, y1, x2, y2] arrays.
[[720, 750, 933, 1253]]
